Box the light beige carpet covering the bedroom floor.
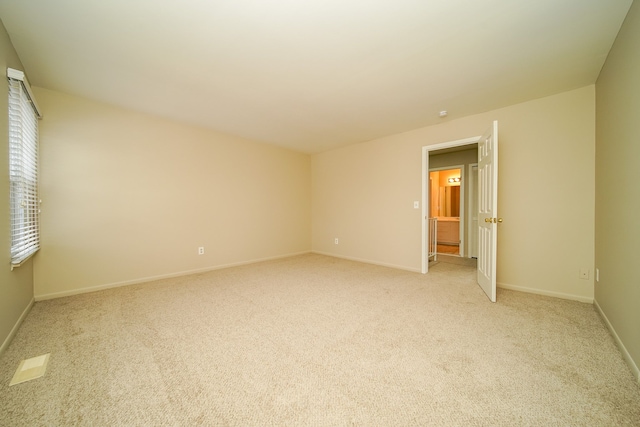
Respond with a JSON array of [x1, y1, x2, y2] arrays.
[[0, 254, 640, 426]]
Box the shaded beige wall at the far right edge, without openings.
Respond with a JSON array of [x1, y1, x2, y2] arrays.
[[595, 2, 640, 381]]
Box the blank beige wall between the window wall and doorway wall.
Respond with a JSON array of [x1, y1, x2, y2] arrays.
[[34, 88, 311, 299]]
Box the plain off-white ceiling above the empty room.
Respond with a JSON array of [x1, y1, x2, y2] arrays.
[[0, 0, 632, 153]]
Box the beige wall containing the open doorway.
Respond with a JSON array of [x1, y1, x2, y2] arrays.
[[312, 85, 595, 302]]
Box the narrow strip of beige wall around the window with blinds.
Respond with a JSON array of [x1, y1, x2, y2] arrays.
[[0, 22, 33, 352]]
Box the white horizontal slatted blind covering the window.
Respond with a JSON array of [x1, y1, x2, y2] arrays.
[[7, 68, 41, 268]]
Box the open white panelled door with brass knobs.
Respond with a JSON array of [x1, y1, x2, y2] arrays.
[[478, 121, 502, 302]]
